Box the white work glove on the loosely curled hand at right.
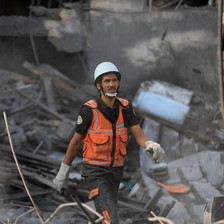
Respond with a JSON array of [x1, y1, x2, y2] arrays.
[[145, 141, 165, 163]]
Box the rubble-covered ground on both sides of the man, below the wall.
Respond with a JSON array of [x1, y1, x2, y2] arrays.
[[0, 62, 224, 224]]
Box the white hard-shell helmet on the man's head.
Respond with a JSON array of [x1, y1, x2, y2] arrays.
[[94, 62, 120, 82]]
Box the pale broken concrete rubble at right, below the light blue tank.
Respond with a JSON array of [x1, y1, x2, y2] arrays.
[[137, 81, 224, 224]]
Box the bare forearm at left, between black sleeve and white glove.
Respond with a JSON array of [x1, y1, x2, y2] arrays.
[[64, 132, 84, 166]]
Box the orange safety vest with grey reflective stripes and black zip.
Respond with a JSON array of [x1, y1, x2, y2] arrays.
[[83, 98, 129, 167]]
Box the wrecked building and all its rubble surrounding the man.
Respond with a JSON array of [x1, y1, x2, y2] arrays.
[[0, 0, 224, 224]]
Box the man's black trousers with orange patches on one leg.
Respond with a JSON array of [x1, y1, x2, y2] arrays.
[[85, 167, 123, 224]]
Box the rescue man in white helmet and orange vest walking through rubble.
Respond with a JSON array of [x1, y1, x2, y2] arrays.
[[53, 62, 164, 224]]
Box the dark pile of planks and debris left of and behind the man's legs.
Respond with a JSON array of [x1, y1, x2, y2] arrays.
[[0, 62, 169, 224]]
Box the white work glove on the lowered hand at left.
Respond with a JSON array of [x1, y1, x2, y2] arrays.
[[53, 162, 71, 193]]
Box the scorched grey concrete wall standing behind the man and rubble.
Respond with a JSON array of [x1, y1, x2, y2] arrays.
[[0, 0, 218, 97]]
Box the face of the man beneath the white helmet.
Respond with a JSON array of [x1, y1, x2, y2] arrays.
[[97, 73, 120, 93]]
